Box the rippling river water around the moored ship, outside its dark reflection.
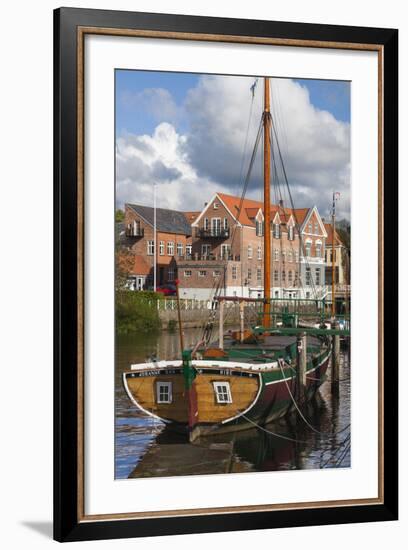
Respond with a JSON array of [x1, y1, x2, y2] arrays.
[[115, 329, 351, 479]]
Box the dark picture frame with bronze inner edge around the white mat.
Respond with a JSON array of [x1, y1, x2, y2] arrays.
[[54, 8, 398, 542]]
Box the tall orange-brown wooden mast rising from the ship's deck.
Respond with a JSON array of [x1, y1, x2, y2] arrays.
[[263, 77, 271, 327]]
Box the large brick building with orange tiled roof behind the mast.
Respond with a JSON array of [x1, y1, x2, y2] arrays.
[[177, 193, 327, 299]]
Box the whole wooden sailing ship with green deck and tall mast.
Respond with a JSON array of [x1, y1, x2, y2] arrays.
[[123, 78, 331, 441]]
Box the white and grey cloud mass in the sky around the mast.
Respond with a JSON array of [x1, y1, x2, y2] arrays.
[[117, 76, 350, 217]]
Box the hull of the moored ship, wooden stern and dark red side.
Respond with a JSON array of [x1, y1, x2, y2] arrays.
[[123, 348, 330, 440]]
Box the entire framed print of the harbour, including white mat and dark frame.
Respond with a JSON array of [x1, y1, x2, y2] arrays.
[[54, 8, 398, 541]]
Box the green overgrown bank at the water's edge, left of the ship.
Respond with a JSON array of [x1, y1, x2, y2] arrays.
[[115, 290, 160, 334]]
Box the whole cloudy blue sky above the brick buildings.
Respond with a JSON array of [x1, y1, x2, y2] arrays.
[[115, 70, 350, 218]]
